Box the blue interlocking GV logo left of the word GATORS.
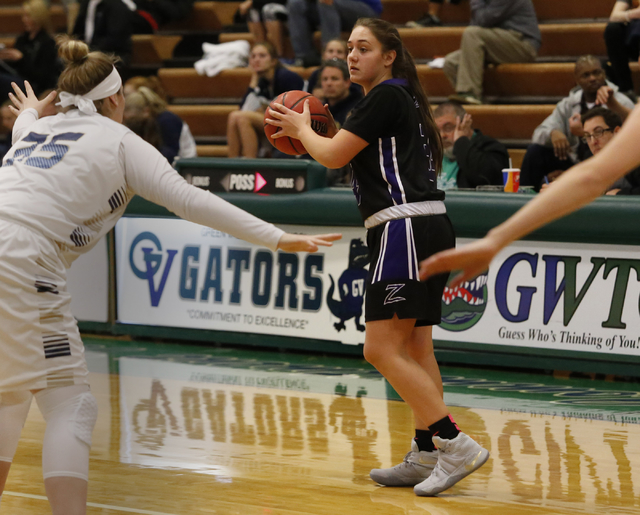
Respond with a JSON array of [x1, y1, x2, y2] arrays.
[[129, 231, 178, 308]]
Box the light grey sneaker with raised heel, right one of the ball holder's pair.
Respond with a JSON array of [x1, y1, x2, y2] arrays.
[[413, 433, 489, 497]]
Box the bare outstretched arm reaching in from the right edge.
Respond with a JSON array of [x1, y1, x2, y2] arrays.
[[420, 105, 640, 285]]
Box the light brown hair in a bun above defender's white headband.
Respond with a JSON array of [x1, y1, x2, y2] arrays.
[[56, 35, 118, 111]]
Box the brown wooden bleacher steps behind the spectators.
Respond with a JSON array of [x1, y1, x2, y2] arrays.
[[0, 0, 624, 159]]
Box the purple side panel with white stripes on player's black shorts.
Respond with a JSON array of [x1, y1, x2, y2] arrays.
[[372, 218, 416, 283]]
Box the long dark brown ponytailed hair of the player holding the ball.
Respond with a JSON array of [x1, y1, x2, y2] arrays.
[[355, 18, 443, 173]]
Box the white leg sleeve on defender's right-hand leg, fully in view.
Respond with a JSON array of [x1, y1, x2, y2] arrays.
[[35, 385, 98, 481]]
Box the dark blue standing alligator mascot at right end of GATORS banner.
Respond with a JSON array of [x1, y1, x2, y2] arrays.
[[327, 238, 369, 332]]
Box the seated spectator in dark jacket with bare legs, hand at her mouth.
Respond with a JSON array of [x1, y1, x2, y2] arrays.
[[227, 42, 304, 157]]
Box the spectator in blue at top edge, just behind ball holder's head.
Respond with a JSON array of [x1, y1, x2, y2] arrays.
[[287, 0, 382, 66]]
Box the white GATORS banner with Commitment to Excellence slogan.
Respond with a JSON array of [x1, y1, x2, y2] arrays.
[[116, 217, 368, 345]]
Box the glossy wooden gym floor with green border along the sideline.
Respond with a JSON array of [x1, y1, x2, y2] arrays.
[[0, 338, 640, 515]]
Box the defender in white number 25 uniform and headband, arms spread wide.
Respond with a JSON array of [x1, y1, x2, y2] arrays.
[[0, 39, 340, 515]]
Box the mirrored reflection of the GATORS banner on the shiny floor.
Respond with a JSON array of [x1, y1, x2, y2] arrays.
[[120, 358, 389, 482]]
